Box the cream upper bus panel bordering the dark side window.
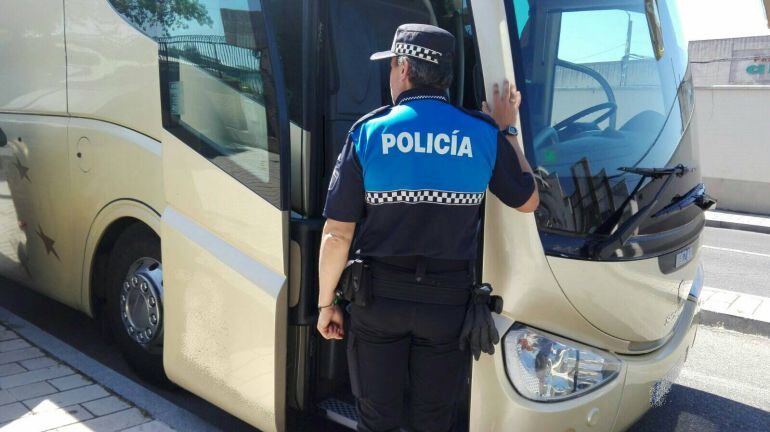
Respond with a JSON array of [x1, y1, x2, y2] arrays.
[[65, 0, 163, 140]]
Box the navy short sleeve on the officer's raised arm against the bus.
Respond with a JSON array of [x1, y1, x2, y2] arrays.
[[489, 133, 535, 208]]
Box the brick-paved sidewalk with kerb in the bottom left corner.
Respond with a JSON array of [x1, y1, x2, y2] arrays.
[[0, 307, 218, 432]]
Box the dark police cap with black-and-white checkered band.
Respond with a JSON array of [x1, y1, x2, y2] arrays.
[[369, 24, 455, 64]]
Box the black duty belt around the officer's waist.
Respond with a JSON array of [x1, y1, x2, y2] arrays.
[[369, 260, 473, 306]]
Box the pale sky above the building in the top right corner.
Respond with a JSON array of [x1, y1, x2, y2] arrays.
[[676, 0, 770, 40]]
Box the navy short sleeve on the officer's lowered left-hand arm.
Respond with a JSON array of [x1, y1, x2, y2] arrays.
[[324, 136, 364, 222]]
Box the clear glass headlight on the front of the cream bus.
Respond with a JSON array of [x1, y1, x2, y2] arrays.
[[503, 323, 621, 402]]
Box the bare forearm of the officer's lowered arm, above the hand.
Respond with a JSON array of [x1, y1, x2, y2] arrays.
[[318, 219, 356, 306]]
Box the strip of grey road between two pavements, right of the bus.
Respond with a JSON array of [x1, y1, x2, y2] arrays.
[[701, 227, 770, 297]]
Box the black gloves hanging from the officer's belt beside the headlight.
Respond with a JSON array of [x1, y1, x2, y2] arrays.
[[460, 284, 503, 360]]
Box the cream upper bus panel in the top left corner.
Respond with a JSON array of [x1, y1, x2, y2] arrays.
[[0, 0, 67, 115]]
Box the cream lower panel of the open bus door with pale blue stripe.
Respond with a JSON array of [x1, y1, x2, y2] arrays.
[[161, 134, 288, 431]]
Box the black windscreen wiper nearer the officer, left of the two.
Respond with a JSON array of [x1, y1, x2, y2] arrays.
[[590, 164, 690, 258]]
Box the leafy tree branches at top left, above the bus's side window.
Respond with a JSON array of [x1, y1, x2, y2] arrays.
[[110, 0, 213, 36]]
